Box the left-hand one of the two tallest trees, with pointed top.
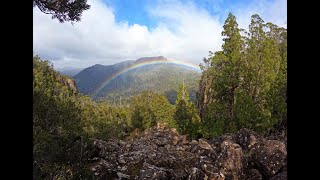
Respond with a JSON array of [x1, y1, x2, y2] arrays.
[[200, 13, 243, 135]]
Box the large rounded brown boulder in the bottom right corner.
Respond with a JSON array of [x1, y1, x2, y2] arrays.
[[251, 140, 287, 177]]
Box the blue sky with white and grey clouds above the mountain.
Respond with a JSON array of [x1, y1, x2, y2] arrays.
[[33, 0, 287, 69]]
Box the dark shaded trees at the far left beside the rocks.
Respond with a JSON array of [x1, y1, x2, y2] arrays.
[[33, 56, 90, 179]]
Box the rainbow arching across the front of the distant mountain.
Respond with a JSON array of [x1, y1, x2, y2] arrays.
[[92, 60, 200, 97]]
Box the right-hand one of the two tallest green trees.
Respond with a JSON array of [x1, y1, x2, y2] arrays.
[[238, 14, 281, 132]]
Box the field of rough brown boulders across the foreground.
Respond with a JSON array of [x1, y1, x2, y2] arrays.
[[88, 124, 287, 180]]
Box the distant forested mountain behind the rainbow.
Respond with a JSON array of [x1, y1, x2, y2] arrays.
[[74, 56, 201, 103]]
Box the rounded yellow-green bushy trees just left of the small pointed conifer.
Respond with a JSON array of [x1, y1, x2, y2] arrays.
[[130, 91, 176, 129]]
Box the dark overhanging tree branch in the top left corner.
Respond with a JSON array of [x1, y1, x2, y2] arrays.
[[33, 0, 90, 23]]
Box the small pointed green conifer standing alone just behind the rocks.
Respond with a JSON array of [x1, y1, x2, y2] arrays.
[[174, 83, 200, 137]]
